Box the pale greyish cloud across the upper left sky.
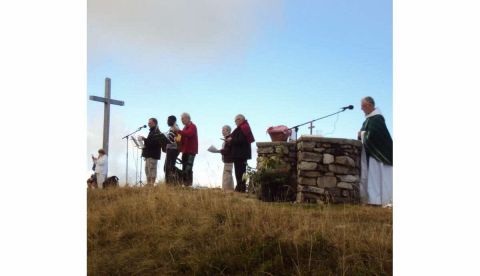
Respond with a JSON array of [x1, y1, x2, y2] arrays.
[[88, 0, 282, 66]]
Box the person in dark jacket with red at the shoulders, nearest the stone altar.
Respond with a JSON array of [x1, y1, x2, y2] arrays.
[[226, 114, 255, 193]]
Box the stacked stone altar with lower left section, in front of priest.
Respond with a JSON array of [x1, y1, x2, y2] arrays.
[[257, 136, 362, 203]]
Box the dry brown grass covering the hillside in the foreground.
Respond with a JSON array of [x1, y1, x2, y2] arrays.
[[87, 185, 392, 275]]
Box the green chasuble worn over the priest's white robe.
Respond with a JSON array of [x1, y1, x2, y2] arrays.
[[361, 114, 393, 166]]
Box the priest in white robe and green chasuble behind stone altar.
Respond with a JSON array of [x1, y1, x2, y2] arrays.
[[358, 97, 393, 206]]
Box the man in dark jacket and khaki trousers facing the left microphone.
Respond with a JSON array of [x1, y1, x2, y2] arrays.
[[138, 118, 161, 186]]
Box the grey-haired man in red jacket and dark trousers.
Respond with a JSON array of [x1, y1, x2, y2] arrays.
[[178, 113, 198, 186]]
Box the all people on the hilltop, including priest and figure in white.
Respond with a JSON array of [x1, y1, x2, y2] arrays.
[[88, 97, 393, 206]]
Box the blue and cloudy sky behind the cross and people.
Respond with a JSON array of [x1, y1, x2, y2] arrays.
[[85, 0, 395, 187]]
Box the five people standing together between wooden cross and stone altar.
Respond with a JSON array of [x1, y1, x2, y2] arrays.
[[138, 113, 255, 192]]
